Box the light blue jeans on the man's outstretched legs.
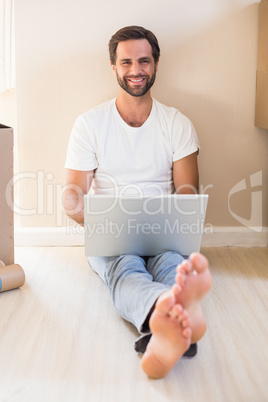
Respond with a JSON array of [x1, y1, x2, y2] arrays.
[[88, 252, 184, 351]]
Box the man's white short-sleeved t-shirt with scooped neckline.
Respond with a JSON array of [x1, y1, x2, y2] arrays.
[[65, 99, 199, 195]]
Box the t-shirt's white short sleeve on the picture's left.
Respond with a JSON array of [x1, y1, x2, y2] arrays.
[[64, 115, 98, 171]]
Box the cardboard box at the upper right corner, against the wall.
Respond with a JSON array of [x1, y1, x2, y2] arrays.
[[255, 0, 268, 129]]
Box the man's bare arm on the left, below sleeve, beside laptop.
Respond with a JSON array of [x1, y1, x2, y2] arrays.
[[63, 169, 94, 225]]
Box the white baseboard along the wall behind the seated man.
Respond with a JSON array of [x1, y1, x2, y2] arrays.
[[15, 226, 268, 247]]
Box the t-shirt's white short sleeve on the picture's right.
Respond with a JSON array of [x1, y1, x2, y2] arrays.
[[171, 111, 200, 162]]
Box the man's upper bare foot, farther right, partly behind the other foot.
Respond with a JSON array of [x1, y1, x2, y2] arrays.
[[173, 253, 212, 343]]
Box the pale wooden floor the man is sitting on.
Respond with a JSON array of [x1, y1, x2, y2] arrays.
[[0, 247, 268, 402]]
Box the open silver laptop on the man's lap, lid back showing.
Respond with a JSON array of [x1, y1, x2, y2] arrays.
[[84, 194, 208, 256]]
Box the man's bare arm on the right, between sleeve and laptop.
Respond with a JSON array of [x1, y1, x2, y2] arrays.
[[173, 152, 199, 194]]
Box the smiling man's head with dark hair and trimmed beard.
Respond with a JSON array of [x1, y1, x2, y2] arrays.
[[109, 26, 160, 97]]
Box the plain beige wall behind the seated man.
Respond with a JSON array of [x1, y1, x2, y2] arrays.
[[15, 0, 268, 231]]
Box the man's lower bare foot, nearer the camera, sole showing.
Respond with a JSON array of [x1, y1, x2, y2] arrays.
[[142, 290, 192, 378]]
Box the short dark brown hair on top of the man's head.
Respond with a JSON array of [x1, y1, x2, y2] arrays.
[[109, 25, 160, 65]]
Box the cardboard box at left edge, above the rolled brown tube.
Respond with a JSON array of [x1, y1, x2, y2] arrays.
[[0, 124, 14, 265]]
